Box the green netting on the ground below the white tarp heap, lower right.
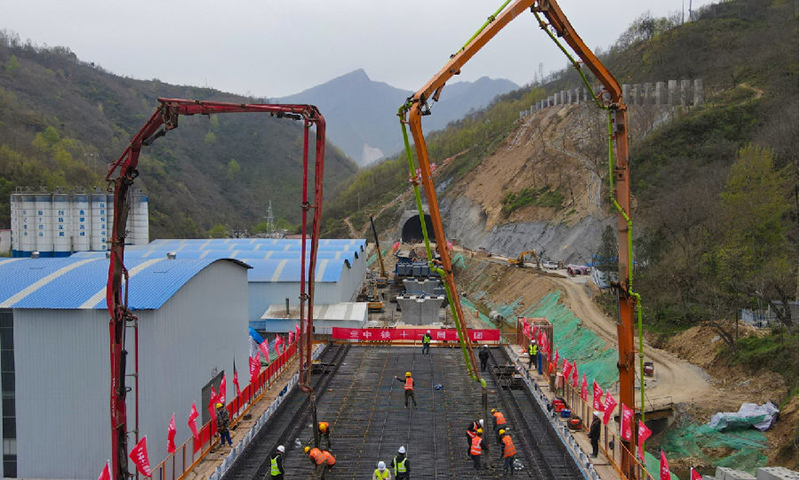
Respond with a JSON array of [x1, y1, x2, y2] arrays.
[[661, 422, 768, 474]]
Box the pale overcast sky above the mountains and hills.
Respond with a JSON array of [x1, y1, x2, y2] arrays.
[[0, 0, 715, 98]]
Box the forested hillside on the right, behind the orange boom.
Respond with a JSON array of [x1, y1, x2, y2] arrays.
[[326, 0, 800, 382]]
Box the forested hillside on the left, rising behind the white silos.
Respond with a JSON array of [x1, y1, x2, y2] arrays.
[[0, 32, 356, 238]]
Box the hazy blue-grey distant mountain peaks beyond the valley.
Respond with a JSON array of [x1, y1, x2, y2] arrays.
[[276, 69, 519, 166]]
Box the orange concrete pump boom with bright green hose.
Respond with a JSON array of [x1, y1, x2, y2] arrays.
[[398, 0, 644, 478]]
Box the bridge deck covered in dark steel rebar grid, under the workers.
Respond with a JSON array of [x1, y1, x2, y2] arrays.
[[224, 345, 583, 480]]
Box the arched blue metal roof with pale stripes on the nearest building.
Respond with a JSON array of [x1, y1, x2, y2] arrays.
[[0, 253, 248, 310]]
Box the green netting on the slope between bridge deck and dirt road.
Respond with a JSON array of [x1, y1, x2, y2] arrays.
[[522, 290, 619, 389]]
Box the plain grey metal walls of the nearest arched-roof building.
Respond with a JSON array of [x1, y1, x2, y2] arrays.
[[14, 262, 248, 479]]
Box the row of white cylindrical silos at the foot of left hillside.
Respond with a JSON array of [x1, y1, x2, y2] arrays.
[[10, 189, 149, 257]]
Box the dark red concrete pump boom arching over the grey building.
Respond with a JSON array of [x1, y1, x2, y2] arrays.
[[106, 98, 325, 480]]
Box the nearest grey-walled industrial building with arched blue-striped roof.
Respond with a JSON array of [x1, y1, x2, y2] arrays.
[[0, 256, 248, 479]]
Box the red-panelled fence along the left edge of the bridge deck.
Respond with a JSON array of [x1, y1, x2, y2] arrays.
[[151, 343, 297, 480]]
